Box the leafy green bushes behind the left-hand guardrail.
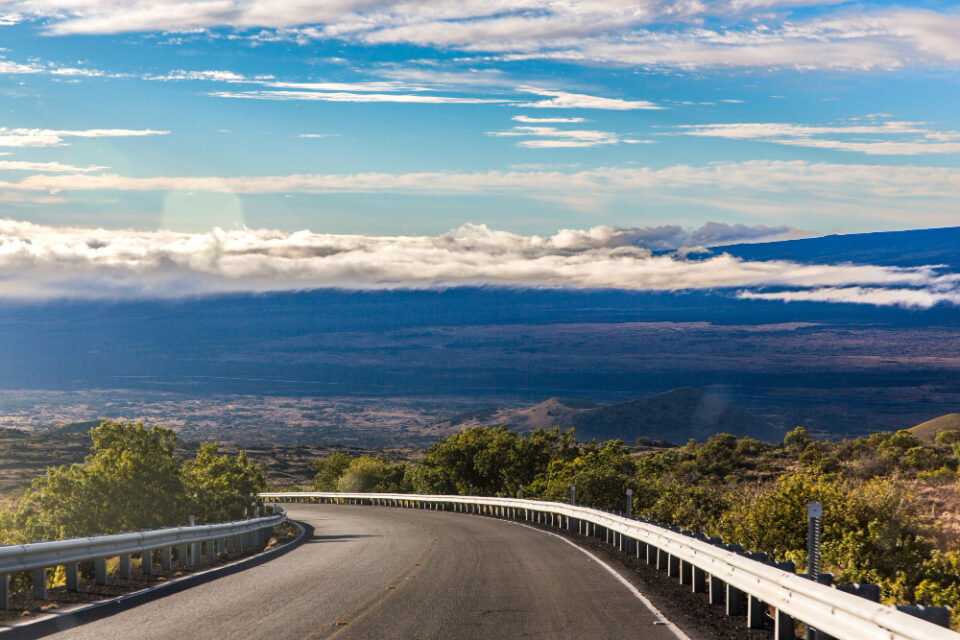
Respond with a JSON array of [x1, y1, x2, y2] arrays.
[[0, 421, 266, 544]]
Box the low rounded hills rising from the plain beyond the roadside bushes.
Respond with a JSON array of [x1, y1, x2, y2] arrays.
[[430, 387, 782, 444]]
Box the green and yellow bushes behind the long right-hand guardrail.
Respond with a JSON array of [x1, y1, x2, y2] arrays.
[[314, 427, 960, 626]]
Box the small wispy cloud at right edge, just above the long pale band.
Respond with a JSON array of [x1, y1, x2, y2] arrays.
[[678, 118, 960, 155]]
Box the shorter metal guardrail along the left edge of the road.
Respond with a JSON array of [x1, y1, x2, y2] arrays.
[[0, 507, 287, 609]]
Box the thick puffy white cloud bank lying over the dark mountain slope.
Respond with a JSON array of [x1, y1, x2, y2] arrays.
[[0, 219, 948, 308]]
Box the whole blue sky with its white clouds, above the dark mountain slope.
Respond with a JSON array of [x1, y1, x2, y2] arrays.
[[0, 0, 960, 304]]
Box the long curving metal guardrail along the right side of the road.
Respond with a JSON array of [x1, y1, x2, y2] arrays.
[[260, 492, 960, 640]]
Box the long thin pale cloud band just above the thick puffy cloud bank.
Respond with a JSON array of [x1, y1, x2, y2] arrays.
[[9, 160, 960, 227]]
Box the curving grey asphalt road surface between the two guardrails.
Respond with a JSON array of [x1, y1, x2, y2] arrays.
[[48, 505, 678, 640]]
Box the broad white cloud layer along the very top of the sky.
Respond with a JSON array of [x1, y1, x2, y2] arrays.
[[5, 0, 960, 70]]
